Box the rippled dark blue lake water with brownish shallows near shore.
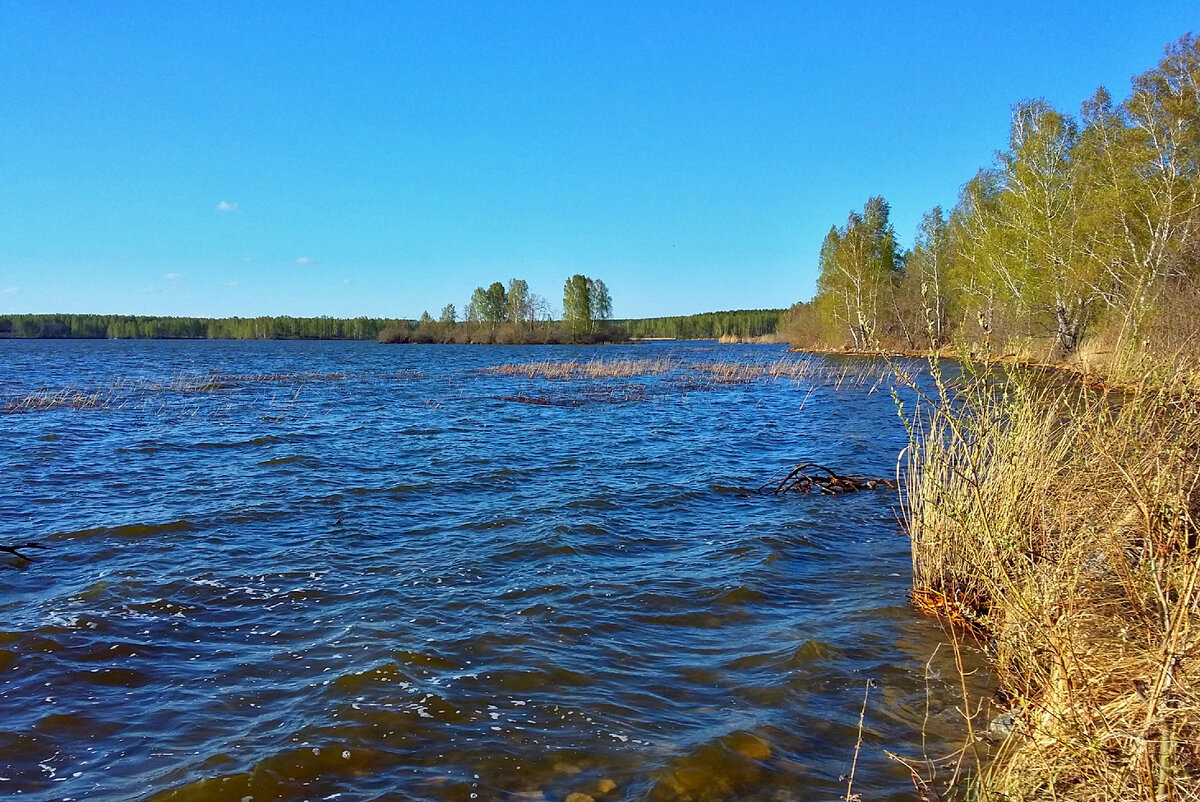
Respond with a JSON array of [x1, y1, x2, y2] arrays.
[[0, 341, 984, 802]]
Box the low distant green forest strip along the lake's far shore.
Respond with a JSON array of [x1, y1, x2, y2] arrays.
[[0, 310, 784, 341]]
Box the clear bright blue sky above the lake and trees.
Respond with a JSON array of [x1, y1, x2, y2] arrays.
[[0, 0, 1200, 317]]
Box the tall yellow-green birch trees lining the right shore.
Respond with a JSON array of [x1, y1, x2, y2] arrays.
[[784, 34, 1200, 355]]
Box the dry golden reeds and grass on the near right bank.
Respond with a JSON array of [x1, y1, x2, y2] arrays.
[[902, 352, 1200, 802]]
